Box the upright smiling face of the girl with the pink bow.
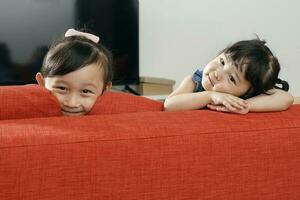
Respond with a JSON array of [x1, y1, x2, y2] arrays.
[[36, 64, 106, 116]]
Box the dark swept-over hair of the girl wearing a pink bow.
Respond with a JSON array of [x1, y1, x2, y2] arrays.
[[41, 36, 113, 85]]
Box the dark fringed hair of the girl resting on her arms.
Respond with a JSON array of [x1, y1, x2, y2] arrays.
[[221, 38, 289, 99]]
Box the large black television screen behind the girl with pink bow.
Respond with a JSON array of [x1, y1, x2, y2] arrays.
[[0, 0, 139, 85]]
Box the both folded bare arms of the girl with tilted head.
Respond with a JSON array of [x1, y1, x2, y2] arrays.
[[164, 76, 294, 114]]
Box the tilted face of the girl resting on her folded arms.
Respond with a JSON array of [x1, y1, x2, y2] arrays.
[[202, 53, 251, 97]]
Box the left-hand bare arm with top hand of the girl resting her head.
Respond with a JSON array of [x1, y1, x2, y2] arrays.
[[164, 75, 247, 112]]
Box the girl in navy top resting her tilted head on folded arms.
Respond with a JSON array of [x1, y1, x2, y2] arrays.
[[164, 39, 294, 114]]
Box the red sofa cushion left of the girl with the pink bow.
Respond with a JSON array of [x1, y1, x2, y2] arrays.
[[0, 84, 62, 119]]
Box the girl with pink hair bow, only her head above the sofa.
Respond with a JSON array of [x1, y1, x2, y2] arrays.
[[36, 29, 112, 116]]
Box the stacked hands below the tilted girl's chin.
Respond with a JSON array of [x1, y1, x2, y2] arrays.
[[207, 92, 249, 114]]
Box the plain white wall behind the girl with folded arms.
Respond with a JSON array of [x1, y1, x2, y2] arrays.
[[140, 0, 300, 96]]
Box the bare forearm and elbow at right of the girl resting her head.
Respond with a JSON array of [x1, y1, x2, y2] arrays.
[[247, 89, 294, 112]]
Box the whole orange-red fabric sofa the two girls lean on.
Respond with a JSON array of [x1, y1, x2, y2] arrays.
[[0, 86, 300, 200]]
